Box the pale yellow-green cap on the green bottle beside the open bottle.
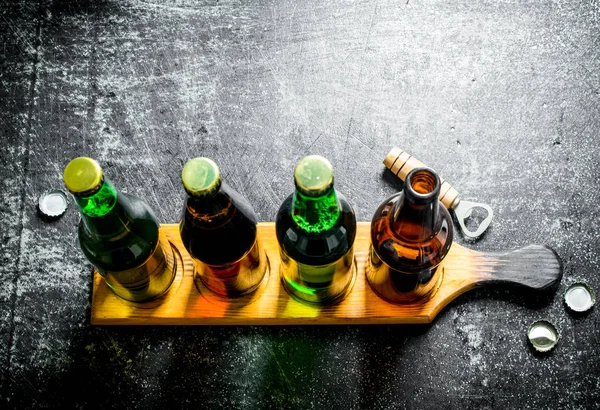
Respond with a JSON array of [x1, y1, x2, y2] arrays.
[[294, 155, 333, 197]]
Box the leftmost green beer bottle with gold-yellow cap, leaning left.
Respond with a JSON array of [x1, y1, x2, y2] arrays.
[[63, 157, 175, 302]]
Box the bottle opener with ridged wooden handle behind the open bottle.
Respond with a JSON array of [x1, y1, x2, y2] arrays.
[[383, 147, 494, 239]]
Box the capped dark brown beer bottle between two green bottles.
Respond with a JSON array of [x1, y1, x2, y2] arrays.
[[179, 158, 267, 297]]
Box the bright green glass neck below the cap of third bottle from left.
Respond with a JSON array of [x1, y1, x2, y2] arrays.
[[292, 186, 340, 233]]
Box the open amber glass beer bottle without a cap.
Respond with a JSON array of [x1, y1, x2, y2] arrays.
[[366, 168, 453, 302]]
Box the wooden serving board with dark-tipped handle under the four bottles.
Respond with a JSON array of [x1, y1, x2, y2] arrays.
[[91, 222, 562, 325]]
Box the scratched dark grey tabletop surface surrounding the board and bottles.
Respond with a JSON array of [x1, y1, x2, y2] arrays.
[[0, 0, 600, 409]]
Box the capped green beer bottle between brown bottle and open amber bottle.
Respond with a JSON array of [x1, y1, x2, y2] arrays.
[[275, 155, 356, 305]]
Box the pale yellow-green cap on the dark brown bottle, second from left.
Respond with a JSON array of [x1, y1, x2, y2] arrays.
[[181, 157, 221, 198]]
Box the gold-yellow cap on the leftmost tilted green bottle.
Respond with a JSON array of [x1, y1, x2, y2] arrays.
[[63, 157, 104, 196]]
